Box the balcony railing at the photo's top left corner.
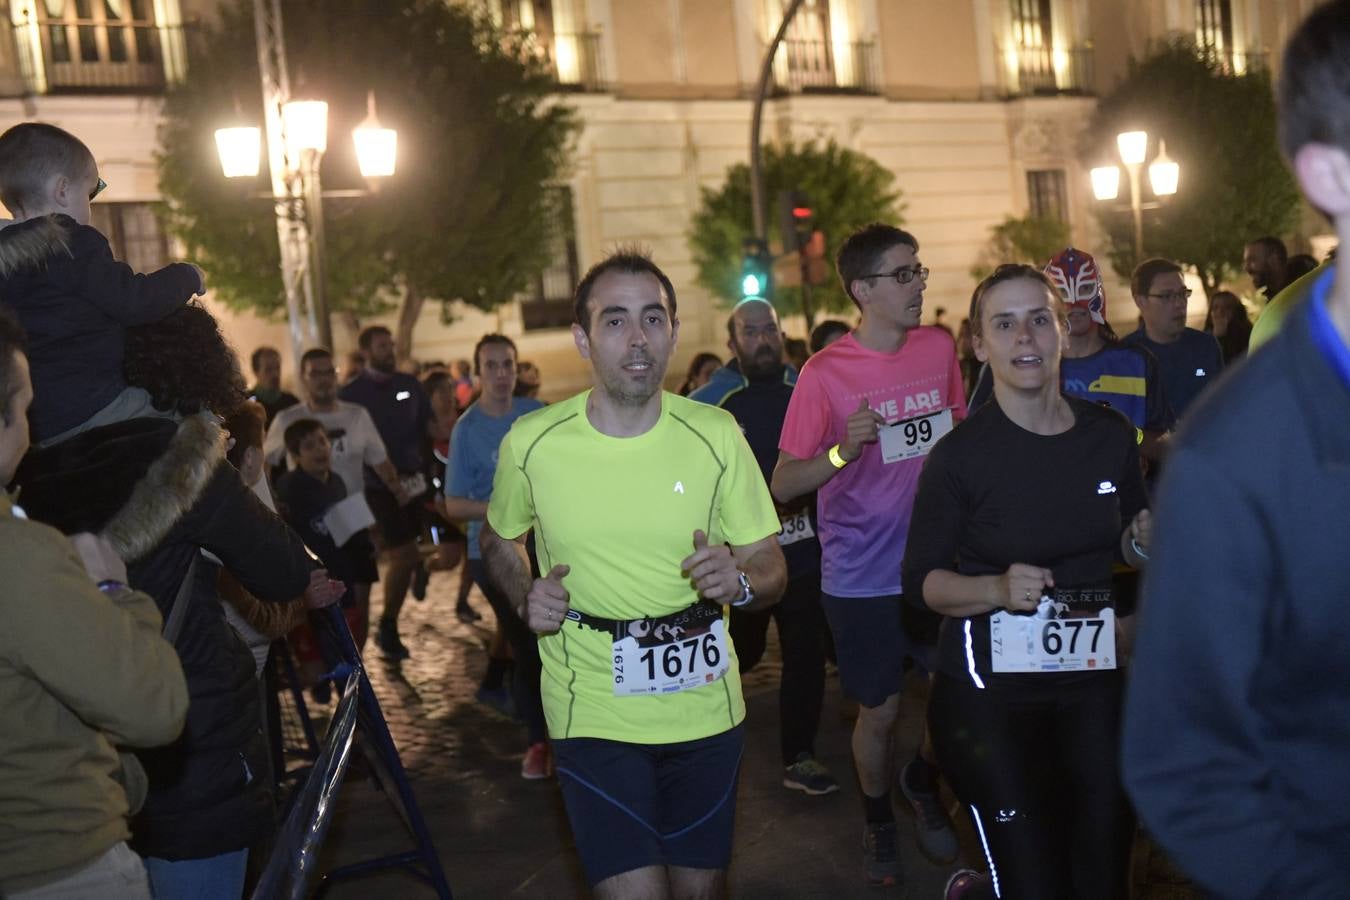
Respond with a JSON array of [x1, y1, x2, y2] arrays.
[[14, 19, 185, 93]]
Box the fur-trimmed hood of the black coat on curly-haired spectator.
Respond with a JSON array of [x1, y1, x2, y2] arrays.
[[15, 413, 225, 563]]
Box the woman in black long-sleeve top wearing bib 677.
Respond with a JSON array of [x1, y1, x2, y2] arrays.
[[903, 266, 1149, 900]]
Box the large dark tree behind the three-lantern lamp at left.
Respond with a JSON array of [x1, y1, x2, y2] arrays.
[[158, 0, 579, 355]]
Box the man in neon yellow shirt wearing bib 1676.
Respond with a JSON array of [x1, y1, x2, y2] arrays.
[[482, 252, 787, 899]]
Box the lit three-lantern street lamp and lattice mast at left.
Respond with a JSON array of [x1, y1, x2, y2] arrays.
[[207, 0, 397, 371]]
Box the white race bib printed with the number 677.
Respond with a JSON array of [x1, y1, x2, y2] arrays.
[[990, 598, 1116, 672]]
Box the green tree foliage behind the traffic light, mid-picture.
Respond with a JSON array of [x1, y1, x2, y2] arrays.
[[689, 140, 903, 322]]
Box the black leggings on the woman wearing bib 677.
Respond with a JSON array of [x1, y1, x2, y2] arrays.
[[929, 672, 1134, 900]]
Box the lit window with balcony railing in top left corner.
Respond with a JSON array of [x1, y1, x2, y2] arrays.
[[15, 0, 182, 93]]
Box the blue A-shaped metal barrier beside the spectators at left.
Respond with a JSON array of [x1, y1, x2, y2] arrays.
[[252, 606, 452, 900]]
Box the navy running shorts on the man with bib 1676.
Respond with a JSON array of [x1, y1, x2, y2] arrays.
[[554, 725, 745, 887]]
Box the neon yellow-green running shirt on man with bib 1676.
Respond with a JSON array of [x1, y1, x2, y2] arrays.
[[487, 391, 779, 743]]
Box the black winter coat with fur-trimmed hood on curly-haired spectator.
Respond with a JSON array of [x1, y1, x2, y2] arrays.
[[18, 414, 313, 860]]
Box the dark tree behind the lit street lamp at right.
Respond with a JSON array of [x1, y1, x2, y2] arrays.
[[1080, 39, 1300, 294]]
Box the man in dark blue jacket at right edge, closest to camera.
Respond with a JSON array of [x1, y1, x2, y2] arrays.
[[1123, 0, 1350, 897]]
